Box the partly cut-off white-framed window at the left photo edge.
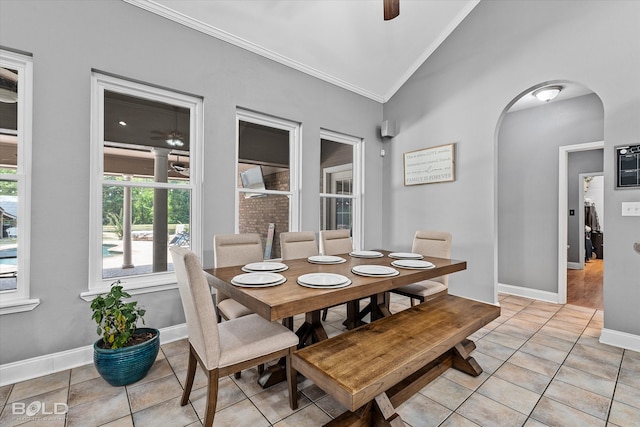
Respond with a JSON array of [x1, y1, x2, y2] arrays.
[[0, 50, 35, 314]]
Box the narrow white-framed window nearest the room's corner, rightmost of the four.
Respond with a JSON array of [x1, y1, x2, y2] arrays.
[[320, 130, 362, 249]]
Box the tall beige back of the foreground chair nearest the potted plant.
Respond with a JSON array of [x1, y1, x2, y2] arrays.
[[169, 246, 220, 369]]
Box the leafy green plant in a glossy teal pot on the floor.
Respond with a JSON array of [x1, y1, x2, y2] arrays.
[[91, 280, 160, 386]]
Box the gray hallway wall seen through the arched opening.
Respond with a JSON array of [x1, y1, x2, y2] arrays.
[[498, 95, 604, 292]]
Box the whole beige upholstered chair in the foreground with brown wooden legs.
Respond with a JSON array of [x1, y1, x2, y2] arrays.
[[170, 246, 298, 427]]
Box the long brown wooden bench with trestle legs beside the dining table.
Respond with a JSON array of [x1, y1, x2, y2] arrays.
[[291, 295, 500, 426]]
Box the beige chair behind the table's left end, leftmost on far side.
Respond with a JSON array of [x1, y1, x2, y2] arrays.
[[213, 233, 263, 320]]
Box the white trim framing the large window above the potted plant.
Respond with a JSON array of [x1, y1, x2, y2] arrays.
[[80, 71, 204, 301]]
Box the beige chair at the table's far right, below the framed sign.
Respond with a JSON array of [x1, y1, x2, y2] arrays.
[[392, 230, 451, 305]]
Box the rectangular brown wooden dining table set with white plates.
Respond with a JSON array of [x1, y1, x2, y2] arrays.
[[205, 250, 467, 387]]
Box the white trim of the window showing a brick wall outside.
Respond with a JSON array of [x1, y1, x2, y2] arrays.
[[234, 108, 302, 233]]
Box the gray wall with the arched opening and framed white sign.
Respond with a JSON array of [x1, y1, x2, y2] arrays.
[[384, 0, 640, 335]]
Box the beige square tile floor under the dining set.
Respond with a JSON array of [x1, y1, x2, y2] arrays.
[[0, 295, 640, 427]]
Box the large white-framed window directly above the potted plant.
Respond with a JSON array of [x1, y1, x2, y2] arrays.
[[83, 73, 202, 298]]
